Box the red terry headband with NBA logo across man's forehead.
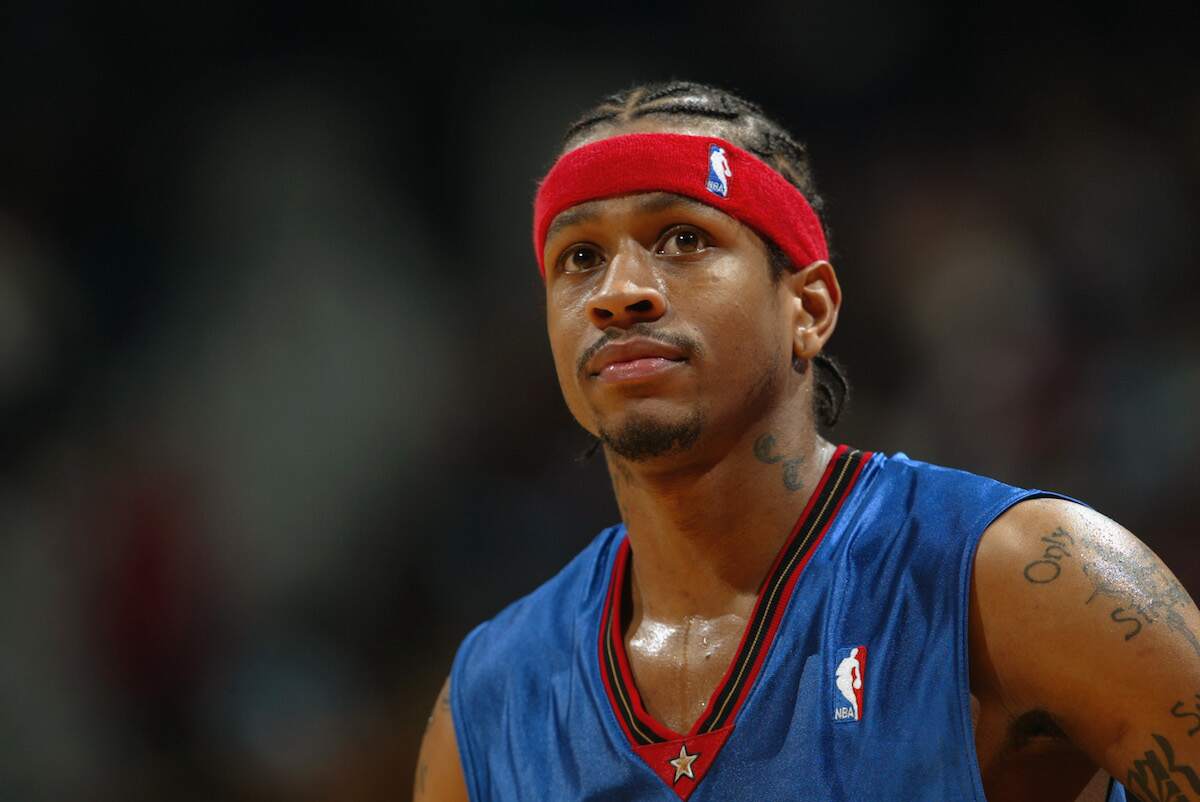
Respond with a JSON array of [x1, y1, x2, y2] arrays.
[[533, 133, 829, 277]]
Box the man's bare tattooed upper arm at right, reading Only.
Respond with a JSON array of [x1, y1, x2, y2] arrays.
[[972, 499, 1200, 802]]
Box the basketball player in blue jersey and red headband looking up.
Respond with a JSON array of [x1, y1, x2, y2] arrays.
[[415, 83, 1200, 802]]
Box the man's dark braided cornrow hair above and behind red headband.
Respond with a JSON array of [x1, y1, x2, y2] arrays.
[[563, 80, 850, 429]]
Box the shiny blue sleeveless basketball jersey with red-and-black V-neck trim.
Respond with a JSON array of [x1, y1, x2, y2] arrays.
[[450, 447, 1124, 802]]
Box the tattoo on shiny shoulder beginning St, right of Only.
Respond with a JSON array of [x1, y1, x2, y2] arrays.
[[1080, 539, 1200, 657]]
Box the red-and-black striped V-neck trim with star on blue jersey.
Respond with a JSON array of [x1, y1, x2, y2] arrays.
[[599, 445, 871, 800]]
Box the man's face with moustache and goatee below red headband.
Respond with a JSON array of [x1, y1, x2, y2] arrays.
[[544, 131, 794, 460]]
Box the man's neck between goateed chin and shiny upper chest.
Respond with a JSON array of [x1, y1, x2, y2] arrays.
[[606, 417, 834, 621]]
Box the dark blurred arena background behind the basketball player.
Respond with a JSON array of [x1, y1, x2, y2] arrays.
[[0, 0, 1200, 802]]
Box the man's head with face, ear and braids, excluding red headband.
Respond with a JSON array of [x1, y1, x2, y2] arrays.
[[542, 83, 847, 460]]
